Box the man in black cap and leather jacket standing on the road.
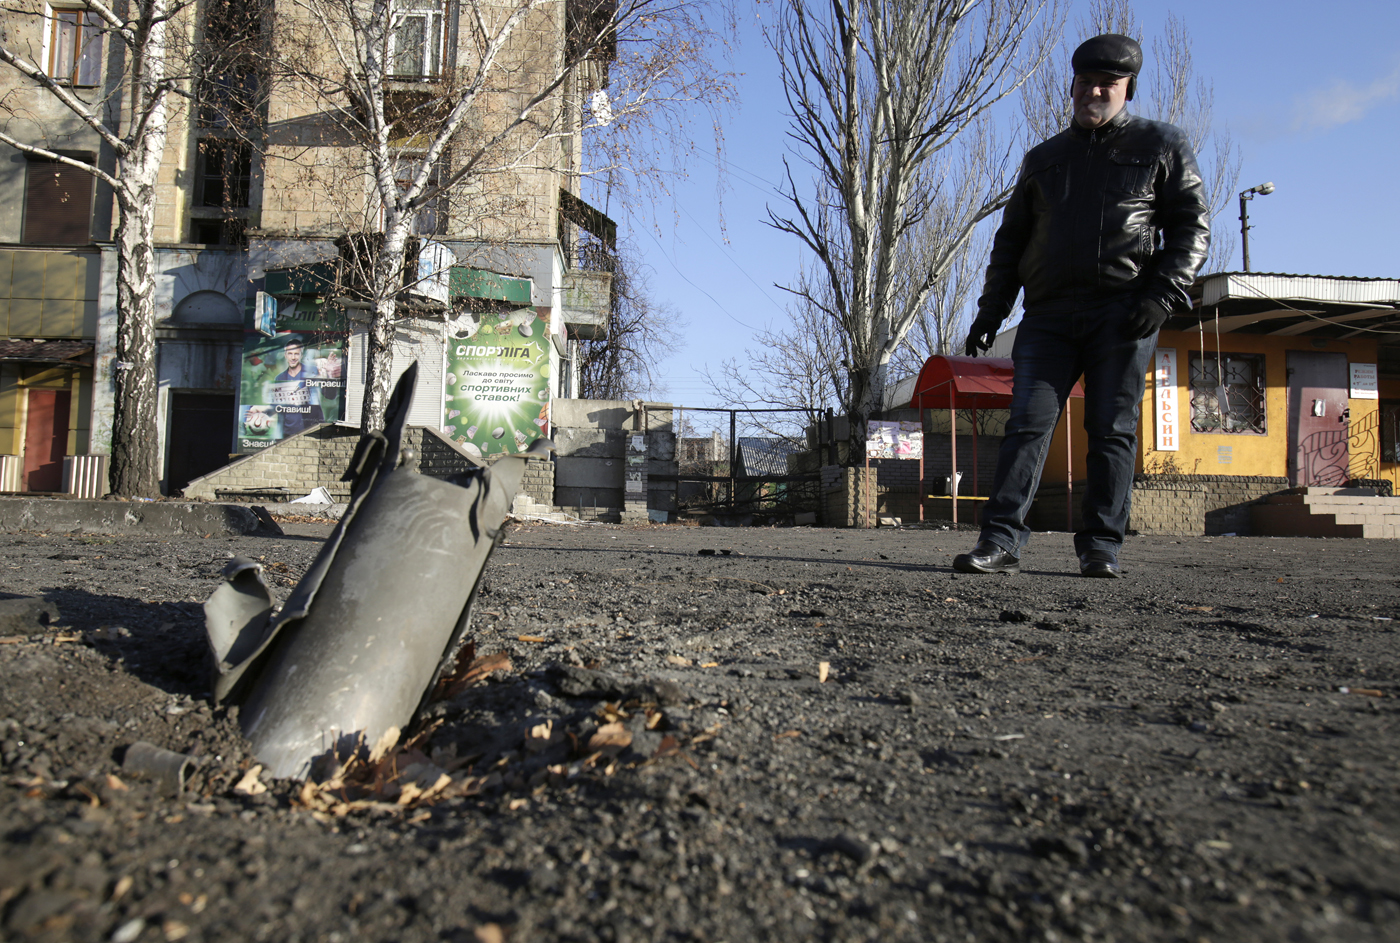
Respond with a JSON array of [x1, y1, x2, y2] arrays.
[[953, 34, 1210, 578]]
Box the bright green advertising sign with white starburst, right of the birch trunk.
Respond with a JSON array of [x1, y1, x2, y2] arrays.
[[442, 308, 549, 456]]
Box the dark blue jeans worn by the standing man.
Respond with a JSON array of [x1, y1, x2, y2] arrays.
[[981, 302, 1156, 554]]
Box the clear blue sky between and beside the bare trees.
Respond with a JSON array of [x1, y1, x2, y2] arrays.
[[627, 0, 1400, 406]]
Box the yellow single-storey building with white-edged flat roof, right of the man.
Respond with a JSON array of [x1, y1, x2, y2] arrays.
[[1138, 273, 1400, 487]]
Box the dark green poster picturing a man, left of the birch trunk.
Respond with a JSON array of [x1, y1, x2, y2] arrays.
[[237, 330, 346, 452]]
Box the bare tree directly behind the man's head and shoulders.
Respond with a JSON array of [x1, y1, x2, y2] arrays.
[[1023, 0, 1240, 271]]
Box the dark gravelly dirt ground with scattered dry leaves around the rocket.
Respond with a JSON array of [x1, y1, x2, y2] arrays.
[[0, 525, 1400, 943]]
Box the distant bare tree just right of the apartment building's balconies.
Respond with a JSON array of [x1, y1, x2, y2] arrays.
[[578, 236, 679, 400]]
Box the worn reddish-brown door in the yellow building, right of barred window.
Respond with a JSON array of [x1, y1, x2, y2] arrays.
[[1288, 350, 1351, 488]]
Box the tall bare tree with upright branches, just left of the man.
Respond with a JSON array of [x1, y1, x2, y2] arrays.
[[769, 0, 1060, 456]]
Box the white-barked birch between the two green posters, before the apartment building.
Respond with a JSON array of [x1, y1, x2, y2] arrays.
[[270, 0, 739, 430]]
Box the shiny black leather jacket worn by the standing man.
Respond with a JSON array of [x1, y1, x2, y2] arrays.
[[977, 111, 1211, 320]]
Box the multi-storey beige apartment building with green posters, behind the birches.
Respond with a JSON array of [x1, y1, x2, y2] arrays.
[[0, 0, 616, 497]]
